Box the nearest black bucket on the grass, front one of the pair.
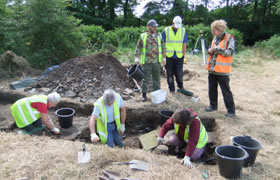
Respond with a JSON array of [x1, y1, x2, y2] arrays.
[[215, 145, 249, 179]]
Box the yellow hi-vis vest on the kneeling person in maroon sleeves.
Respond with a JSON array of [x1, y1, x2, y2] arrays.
[[174, 117, 208, 149]]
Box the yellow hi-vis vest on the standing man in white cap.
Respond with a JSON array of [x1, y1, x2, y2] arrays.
[[164, 26, 186, 58]]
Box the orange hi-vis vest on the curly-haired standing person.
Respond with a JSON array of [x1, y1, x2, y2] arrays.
[[206, 33, 233, 73]]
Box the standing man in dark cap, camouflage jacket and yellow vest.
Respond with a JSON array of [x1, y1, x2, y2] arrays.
[[135, 19, 166, 102]]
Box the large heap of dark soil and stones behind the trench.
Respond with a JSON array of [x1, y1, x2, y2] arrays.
[[38, 54, 134, 101]]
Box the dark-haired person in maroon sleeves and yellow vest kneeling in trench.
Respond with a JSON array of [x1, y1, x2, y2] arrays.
[[157, 108, 208, 168]]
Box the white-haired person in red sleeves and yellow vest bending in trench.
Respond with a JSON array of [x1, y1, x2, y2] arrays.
[[10, 92, 61, 135]]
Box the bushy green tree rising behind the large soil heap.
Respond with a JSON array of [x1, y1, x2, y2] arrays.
[[25, 0, 82, 68]]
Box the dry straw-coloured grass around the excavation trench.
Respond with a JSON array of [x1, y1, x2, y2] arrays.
[[0, 48, 280, 180]]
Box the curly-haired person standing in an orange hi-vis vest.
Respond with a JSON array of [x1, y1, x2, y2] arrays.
[[205, 20, 235, 118]]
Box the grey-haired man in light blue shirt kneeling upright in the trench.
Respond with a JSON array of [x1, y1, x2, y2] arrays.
[[89, 89, 126, 148]]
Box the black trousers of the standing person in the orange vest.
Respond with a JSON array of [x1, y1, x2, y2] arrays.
[[208, 73, 235, 114]]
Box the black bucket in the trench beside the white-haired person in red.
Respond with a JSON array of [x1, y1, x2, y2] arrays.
[[55, 108, 75, 128]]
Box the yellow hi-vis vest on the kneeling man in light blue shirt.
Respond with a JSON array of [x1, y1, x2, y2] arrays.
[[94, 93, 121, 144]]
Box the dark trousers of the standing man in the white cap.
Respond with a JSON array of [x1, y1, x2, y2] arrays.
[[165, 56, 184, 92]]
